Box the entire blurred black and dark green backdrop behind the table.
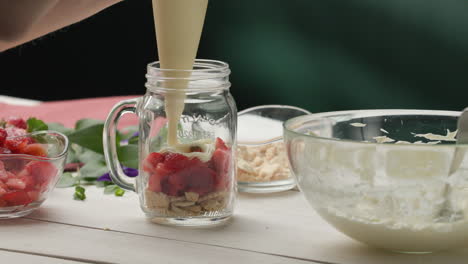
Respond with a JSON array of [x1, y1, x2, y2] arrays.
[[0, 0, 468, 112]]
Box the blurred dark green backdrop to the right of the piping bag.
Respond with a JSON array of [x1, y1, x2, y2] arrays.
[[202, 0, 468, 112]]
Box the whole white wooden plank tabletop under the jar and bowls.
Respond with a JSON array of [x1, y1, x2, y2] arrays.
[[0, 96, 468, 264]]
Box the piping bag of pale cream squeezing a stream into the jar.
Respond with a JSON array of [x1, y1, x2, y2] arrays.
[[153, 0, 208, 146]]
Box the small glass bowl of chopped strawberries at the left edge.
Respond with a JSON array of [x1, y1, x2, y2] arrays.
[[0, 118, 68, 219]]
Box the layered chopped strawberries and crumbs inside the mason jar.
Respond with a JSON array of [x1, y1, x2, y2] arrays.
[[142, 138, 234, 215]]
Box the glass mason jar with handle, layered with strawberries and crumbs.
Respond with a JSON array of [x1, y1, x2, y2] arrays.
[[104, 60, 237, 226]]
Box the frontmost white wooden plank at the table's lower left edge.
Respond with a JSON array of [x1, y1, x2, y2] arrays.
[[0, 219, 318, 264]]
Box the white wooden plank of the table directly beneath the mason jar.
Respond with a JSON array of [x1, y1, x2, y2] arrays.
[[21, 187, 468, 264]]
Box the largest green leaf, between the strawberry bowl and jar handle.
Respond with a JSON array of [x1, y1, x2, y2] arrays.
[[68, 124, 104, 154]]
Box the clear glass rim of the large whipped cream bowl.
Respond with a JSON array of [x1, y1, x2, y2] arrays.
[[283, 109, 462, 148]]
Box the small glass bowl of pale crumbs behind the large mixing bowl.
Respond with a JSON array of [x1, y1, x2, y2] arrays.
[[237, 105, 310, 193]]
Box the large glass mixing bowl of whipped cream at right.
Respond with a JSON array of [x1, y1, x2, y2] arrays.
[[284, 110, 468, 253]]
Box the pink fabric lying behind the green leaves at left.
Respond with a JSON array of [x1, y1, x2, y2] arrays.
[[0, 95, 139, 128]]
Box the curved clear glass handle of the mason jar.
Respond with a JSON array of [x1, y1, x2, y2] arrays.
[[102, 98, 138, 191]]
